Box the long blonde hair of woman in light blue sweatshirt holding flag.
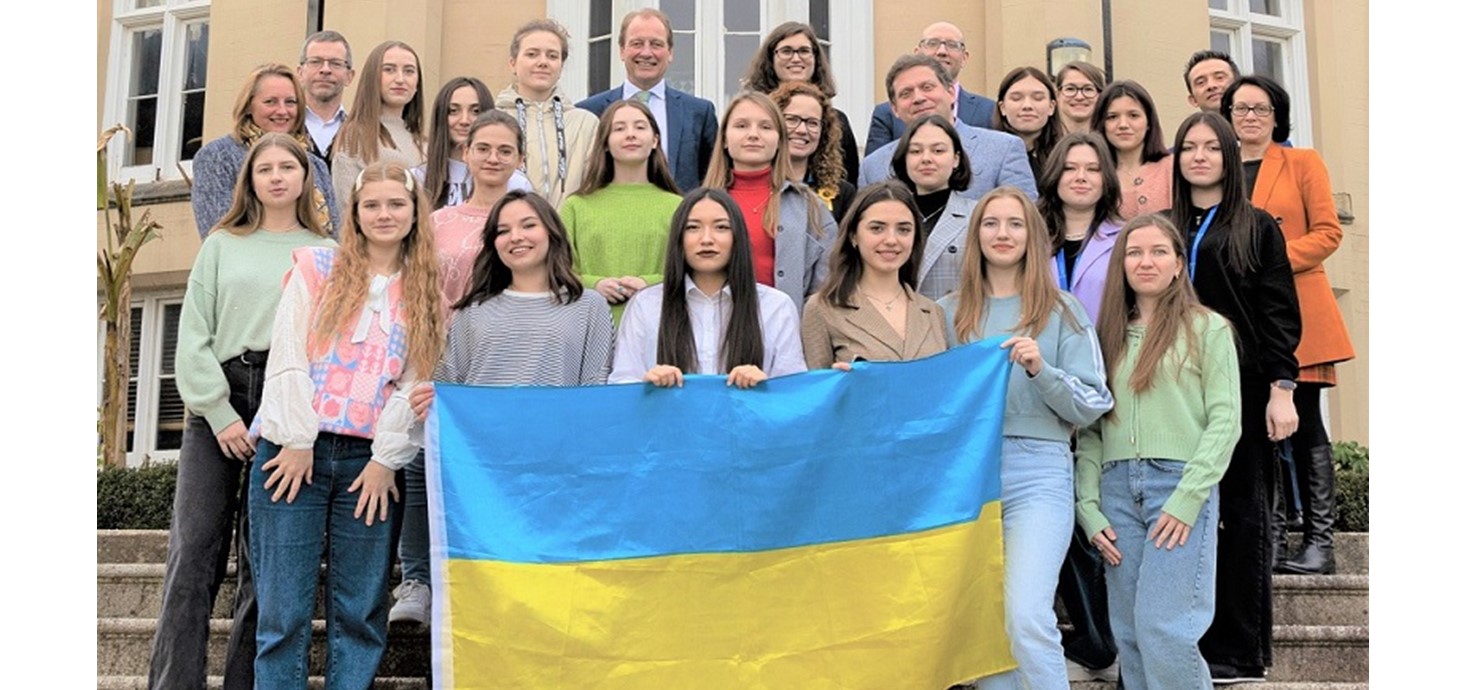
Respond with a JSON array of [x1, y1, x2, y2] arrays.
[[953, 185, 1079, 343]]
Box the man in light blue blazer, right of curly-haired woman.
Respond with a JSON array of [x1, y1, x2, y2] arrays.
[[857, 55, 1040, 201]]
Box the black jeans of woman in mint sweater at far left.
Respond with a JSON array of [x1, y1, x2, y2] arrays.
[[147, 353, 267, 690]]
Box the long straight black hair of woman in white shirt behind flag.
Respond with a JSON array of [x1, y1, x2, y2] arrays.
[[654, 187, 765, 373]]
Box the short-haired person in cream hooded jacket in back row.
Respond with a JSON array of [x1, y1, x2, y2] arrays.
[[496, 19, 599, 207]]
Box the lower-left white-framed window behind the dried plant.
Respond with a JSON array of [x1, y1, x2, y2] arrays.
[[96, 292, 184, 465]]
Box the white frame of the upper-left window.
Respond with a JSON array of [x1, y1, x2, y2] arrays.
[[102, 0, 212, 184]]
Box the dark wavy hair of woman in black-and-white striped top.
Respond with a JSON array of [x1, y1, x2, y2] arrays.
[[453, 190, 583, 309]]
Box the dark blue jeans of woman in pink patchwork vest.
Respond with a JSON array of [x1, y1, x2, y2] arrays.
[[248, 432, 397, 690]]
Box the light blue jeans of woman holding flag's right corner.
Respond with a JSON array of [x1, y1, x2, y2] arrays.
[[978, 436, 1075, 690]]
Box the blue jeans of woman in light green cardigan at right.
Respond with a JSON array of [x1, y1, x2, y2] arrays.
[[1099, 460, 1218, 690]]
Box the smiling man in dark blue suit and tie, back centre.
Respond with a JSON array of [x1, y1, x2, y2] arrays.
[[578, 9, 718, 191]]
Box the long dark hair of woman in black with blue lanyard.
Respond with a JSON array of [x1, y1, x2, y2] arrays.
[[1171, 111, 1257, 273]]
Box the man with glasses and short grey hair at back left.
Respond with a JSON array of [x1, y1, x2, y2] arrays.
[[296, 31, 355, 166]]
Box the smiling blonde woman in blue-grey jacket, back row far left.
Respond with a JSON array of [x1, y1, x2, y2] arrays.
[[193, 64, 340, 239]]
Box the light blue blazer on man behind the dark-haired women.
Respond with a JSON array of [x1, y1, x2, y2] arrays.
[[857, 121, 1040, 201]]
